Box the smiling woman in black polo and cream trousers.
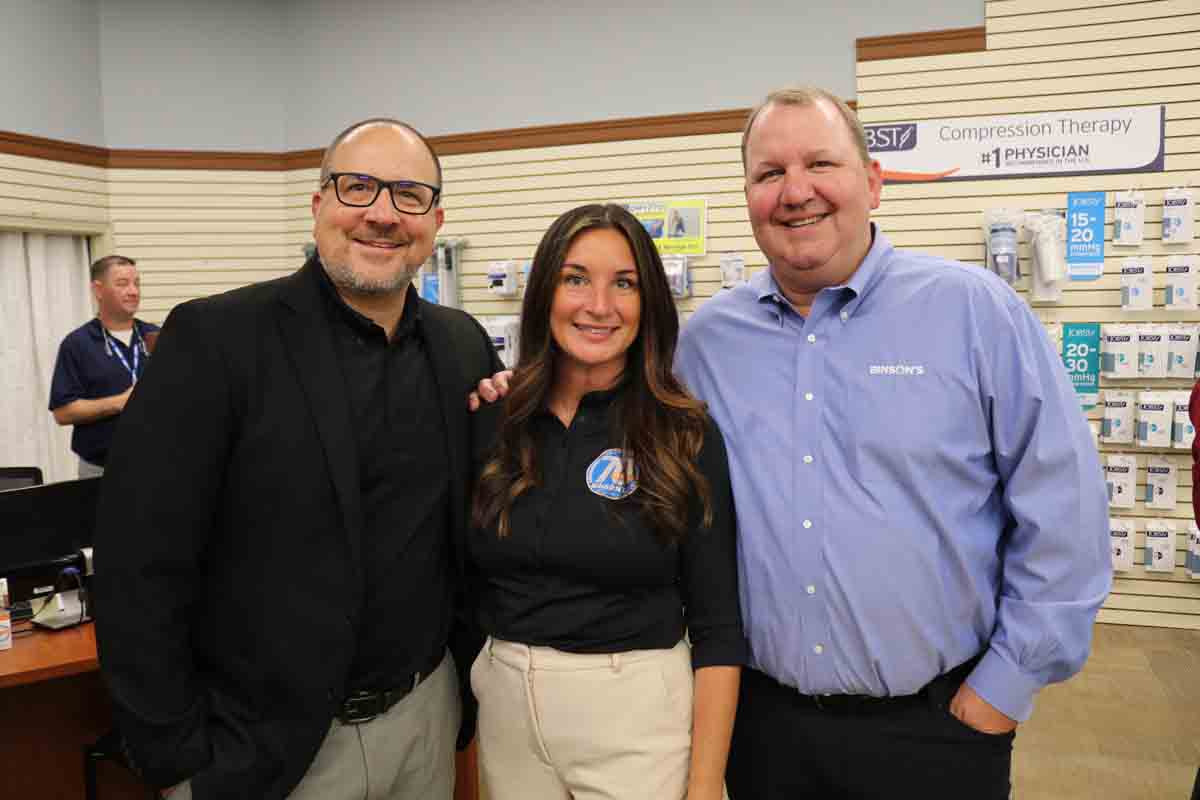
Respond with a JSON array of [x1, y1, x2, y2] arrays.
[[469, 205, 746, 800]]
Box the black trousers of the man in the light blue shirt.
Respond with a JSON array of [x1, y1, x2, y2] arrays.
[[726, 662, 1015, 800]]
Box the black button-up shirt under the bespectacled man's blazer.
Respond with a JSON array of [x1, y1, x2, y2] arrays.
[[320, 271, 452, 691]]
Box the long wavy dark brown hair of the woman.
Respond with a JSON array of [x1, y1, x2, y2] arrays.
[[472, 204, 713, 542]]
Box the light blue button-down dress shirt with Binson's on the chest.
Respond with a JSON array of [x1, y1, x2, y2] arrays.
[[676, 225, 1112, 720]]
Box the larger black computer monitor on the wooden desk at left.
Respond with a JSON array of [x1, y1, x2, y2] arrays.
[[0, 477, 100, 602]]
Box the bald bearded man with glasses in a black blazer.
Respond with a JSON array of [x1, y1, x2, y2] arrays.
[[95, 120, 500, 800]]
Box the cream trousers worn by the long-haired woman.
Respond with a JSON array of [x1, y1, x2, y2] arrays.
[[470, 639, 692, 800]]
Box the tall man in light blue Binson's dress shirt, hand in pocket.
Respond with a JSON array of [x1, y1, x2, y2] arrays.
[[677, 84, 1111, 800]]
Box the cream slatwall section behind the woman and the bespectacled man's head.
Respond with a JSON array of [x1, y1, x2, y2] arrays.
[[279, 133, 766, 317]]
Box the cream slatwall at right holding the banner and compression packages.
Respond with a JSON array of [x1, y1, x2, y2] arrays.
[[857, 0, 1200, 630]]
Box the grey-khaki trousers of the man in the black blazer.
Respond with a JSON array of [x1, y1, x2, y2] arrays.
[[170, 654, 462, 800]]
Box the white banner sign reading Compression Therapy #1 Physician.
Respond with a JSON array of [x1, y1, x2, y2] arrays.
[[864, 106, 1166, 184]]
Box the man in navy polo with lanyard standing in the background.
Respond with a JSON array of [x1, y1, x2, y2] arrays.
[[50, 255, 158, 477]]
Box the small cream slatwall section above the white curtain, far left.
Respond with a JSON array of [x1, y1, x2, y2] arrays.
[[0, 152, 108, 234]]
